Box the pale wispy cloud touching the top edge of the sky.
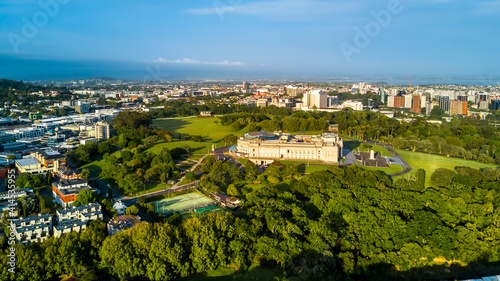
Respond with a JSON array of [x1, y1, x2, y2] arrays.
[[187, 0, 358, 21]]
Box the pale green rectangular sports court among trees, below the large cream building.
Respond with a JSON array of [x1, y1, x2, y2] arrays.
[[153, 192, 215, 215]]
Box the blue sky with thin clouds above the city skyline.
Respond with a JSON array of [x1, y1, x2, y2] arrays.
[[0, 0, 500, 81]]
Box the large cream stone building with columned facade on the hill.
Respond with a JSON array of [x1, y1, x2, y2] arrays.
[[231, 132, 344, 164]]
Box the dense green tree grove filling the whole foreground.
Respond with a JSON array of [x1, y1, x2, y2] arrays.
[[2, 165, 500, 280]]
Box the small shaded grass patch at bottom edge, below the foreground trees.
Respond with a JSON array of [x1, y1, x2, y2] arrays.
[[179, 265, 277, 281]]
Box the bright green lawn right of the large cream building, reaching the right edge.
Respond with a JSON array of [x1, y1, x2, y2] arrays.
[[394, 149, 498, 186]]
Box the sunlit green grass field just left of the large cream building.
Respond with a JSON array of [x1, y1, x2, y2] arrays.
[[148, 117, 248, 160]]
